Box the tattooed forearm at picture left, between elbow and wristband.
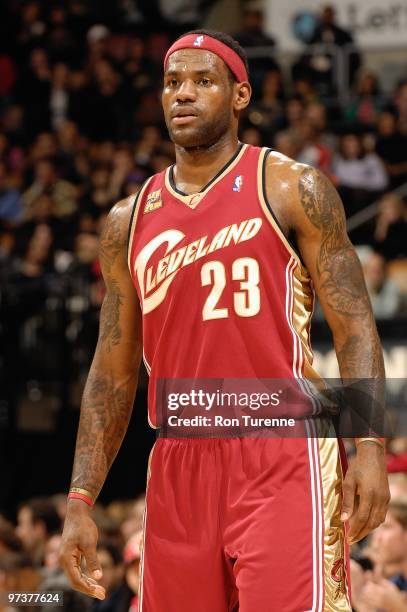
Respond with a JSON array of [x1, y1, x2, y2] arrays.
[[72, 374, 134, 497]]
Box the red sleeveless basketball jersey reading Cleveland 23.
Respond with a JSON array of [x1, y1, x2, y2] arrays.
[[128, 144, 317, 426]]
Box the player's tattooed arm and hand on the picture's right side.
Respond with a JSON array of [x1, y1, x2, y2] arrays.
[[268, 154, 389, 541]]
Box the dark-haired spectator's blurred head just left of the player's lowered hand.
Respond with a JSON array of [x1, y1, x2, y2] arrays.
[[16, 497, 61, 565]]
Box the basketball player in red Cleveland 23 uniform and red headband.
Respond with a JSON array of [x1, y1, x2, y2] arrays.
[[61, 31, 389, 612]]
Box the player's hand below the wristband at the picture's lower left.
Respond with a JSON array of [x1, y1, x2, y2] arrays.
[[59, 499, 106, 599]]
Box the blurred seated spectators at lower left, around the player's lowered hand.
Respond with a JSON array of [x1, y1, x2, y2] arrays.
[[0, 494, 144, 612]]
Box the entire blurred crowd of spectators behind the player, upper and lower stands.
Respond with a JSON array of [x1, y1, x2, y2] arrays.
[[0, 0, 407, 612]]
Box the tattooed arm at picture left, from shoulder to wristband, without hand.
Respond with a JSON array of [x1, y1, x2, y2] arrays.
[[72, 201, 137, 497]]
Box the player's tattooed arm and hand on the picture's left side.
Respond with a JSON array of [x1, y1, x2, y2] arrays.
[[61, 199, 142, 599]]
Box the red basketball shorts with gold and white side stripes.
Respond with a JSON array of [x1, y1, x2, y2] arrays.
[[139, 438, 351, 612]]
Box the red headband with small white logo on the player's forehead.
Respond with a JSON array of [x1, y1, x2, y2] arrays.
[[164, 34, 249, 83]]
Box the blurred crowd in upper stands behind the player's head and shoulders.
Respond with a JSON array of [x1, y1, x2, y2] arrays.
[[0, 0, 407, 332]]
